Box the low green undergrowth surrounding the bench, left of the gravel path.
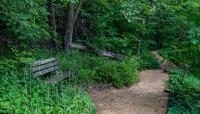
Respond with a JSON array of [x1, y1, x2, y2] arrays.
[[0, 50, 141, 114]]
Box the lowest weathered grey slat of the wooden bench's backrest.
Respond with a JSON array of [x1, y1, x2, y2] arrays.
[[33, 66, 59, 78]]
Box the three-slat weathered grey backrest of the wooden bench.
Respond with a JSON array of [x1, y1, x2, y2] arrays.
[[31, 58, 59, 78]]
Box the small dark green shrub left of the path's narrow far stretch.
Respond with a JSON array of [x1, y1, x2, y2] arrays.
[[139, 51, 160, 69]]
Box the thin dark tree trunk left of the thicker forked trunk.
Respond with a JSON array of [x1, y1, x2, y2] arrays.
[[48, 0, 56, 48]]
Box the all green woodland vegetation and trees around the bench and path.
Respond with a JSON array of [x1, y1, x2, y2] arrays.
[[0, 0, 200, 114]]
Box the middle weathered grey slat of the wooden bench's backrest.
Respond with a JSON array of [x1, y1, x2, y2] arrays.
[[31, 61, 58, 73]]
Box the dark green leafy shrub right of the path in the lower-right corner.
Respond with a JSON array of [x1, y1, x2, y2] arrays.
[[168, 70, 200, 114]]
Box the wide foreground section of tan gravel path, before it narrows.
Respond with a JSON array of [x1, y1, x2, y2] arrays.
[[90, 70, 168, 114]]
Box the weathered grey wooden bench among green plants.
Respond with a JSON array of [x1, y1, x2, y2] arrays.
[[30, 58, 70, 83]]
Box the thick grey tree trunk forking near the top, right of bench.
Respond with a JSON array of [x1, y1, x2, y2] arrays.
[[63, 0, 83, 52]]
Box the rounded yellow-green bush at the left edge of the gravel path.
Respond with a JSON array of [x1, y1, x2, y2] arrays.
[[95, 59, 138, 88]]
